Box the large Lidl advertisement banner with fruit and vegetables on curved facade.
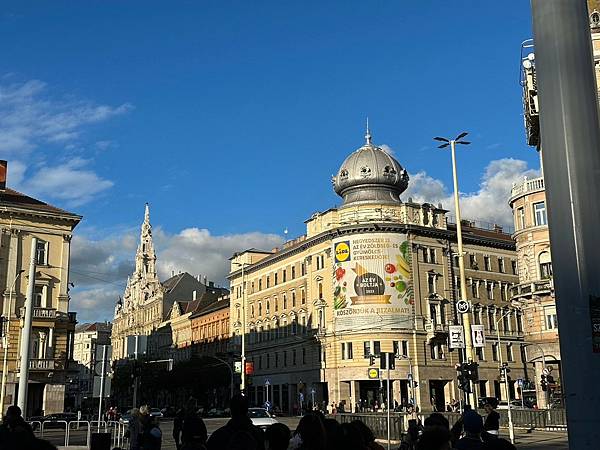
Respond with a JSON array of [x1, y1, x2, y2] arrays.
[[333, 233, 414, 331]]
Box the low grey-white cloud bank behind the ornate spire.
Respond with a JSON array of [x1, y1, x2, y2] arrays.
[[70, 227, 282, 321]]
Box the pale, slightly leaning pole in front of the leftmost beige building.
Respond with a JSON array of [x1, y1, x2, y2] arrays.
[[17, 237, 37, 418]]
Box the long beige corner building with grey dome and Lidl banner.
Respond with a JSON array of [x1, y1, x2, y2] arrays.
[[229, 133, 523, 411]]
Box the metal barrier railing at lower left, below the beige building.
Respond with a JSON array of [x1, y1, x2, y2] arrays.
[[28, 420, 128, 447]]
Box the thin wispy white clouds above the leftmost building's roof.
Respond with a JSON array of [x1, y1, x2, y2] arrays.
[[0, 77, 133, 206]]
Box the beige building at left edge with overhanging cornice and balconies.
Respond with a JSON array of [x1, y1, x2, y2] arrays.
[[0, 161, 81, 415]]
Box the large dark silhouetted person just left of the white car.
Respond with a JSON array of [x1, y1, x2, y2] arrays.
[[206, 395, 265, 450]]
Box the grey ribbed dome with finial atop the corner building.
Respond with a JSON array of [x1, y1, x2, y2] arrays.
[[332, 132, 408, 206]]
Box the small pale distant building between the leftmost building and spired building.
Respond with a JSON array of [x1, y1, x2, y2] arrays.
[[67, 322, 111, 410]]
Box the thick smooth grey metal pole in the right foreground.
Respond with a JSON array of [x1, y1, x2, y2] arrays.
[[531, 0, 600, 444]]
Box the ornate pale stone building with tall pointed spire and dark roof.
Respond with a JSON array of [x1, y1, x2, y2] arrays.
[[111, 204, 221, 360]]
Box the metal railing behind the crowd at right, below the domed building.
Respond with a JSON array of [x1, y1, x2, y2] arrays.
[[334, 409, 567, 440]]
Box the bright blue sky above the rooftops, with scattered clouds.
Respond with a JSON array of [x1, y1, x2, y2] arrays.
[[0, 0, 538, 322]]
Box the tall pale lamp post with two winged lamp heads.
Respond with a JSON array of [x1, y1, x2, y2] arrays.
[[433, 132, 477, 408]]
